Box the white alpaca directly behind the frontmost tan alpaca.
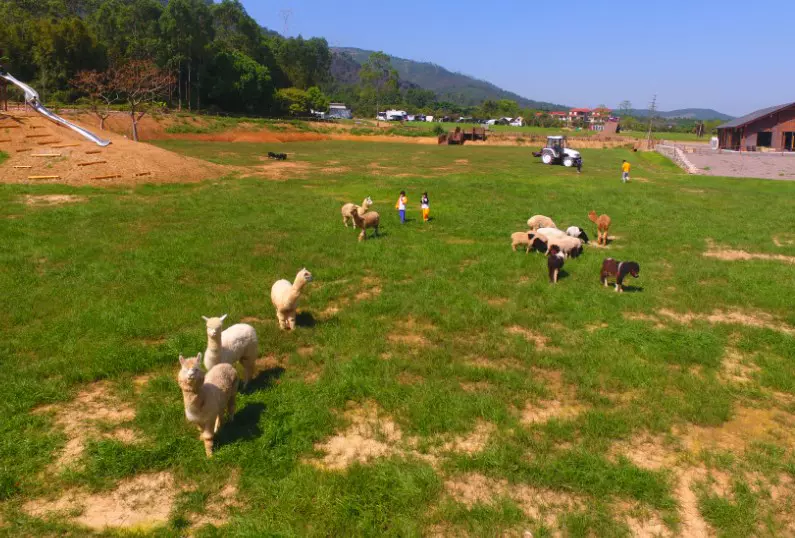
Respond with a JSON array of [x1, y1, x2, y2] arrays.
[[202, 314, 259, 387]]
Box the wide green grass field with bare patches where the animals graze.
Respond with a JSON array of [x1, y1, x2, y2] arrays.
[[0, 141, 795, 537]]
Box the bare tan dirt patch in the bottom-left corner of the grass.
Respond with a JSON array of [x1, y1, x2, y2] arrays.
[[22, 472, 178, 531]]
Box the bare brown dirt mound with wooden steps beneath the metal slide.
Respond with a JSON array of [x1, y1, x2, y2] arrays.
[[0, 113, 232, 186]]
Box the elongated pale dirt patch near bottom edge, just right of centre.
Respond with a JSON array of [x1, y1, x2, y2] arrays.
[[444, 473, 583, 528]]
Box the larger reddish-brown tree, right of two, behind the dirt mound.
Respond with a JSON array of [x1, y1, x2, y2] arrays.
[[111, 60, 174, 142]]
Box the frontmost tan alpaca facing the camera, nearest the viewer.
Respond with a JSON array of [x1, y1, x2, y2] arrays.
[[177, 353, 238, 458]]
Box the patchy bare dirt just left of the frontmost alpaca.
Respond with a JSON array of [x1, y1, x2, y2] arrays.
[[33, 382, 140, 468]]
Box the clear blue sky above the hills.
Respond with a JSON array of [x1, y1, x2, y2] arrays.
[[242, 0, 795, 115]]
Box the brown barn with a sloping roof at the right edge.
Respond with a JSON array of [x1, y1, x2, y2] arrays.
[[718, 103, 795, 151]]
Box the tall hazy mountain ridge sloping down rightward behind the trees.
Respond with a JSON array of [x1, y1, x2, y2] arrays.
[[331, 47, 569, 110]]
